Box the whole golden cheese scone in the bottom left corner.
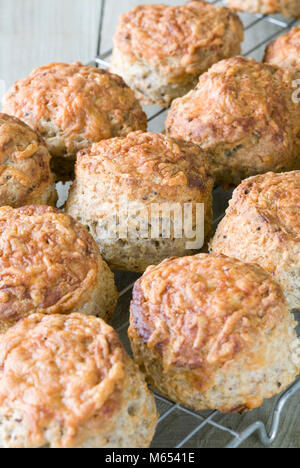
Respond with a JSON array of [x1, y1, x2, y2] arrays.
[[0, 314, 157, 448]]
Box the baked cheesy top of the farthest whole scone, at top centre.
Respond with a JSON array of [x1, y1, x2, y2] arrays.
[[115, 1, 243, 75]]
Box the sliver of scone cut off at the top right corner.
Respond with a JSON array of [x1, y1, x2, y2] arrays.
[[227, 0, 300, 18]]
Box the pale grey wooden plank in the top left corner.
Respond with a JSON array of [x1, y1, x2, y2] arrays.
[[0, 0, 101, 86]]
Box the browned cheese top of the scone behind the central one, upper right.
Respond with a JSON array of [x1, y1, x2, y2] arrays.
[[166, 57, 300, 149]]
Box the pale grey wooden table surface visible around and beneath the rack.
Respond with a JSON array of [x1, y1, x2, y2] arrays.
[[0, 0, 300, 448]]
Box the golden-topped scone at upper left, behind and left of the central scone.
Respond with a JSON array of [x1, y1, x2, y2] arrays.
[[3, 62, 147, 180]]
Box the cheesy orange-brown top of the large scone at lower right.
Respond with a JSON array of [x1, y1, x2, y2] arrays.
[[130, 254, 288, 382]]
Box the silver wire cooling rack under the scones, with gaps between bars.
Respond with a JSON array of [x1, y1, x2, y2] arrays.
[[86, 0, 300, 448]]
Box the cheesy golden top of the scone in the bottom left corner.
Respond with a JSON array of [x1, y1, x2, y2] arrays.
[[0, 314, 128, 448]]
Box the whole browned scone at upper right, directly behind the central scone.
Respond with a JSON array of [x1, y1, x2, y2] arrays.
[[166, 57, 300, 186]]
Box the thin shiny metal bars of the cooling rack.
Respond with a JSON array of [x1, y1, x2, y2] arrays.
[[91, 0, 300, 448]]
